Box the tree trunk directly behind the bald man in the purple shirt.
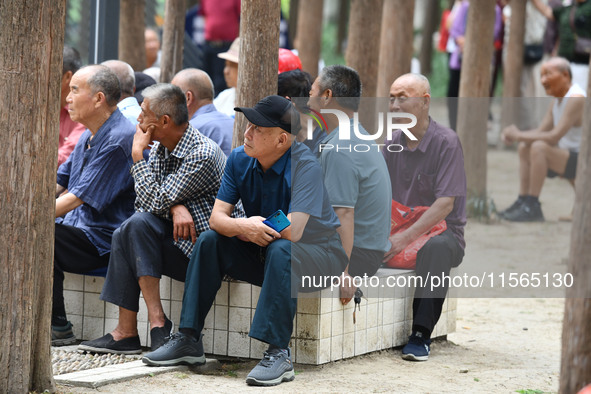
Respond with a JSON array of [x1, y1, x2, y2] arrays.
[[377, 0, 415, 97]]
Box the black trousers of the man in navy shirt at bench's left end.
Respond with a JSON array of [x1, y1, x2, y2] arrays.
[[51, 223, 109, 317]]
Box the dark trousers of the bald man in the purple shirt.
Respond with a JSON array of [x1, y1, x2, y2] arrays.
[[412, 230, 464, 334]]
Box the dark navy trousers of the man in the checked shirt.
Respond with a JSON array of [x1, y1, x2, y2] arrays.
[[101, 212, 189, 312]]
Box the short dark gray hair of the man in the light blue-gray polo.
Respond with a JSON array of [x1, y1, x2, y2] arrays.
[[318, 64, 362, 111]]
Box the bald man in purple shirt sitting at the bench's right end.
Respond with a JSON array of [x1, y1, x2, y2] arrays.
[[383, 74, 466, 361]]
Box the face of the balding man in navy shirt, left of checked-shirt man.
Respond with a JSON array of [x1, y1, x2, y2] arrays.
[[66, 69, 98, 125]]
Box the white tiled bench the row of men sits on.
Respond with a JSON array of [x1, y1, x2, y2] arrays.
[[64, 269, 456, 364]]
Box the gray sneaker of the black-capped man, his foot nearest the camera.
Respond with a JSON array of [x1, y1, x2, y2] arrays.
[[246, 346, 295, 386]]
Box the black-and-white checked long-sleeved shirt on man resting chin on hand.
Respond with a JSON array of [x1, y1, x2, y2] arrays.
[[131, 125, 226, 256]]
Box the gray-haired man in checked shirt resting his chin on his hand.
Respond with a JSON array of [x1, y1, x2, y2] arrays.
[[80, 84, 232, 354]]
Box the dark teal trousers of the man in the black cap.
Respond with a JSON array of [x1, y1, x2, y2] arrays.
[[180, 230, 347, 348]]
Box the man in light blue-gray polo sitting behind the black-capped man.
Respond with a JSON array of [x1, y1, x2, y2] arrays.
[[308, 65, 392, 304]]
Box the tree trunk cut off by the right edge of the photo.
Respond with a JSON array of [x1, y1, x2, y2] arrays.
[[560, 58, 591, 394]]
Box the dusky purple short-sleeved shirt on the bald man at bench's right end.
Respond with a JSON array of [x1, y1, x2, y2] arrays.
[[382, 119, 466, 249]]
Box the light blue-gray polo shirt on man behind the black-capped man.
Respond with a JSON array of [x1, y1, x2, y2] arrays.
[[319, 119, 392, 252]]
